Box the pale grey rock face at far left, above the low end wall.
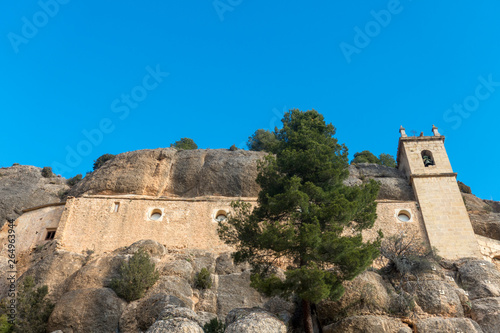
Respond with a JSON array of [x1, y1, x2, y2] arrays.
[[0, 165, 69, 227]]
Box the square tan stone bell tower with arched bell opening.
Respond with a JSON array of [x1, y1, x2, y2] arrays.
[[397, 125, 482, 259]]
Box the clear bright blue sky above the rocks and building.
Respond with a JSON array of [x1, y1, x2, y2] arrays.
[[0, 0, 500, 200]]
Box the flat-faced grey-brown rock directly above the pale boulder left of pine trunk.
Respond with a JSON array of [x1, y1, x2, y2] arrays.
[[217, 271, 267, 317]]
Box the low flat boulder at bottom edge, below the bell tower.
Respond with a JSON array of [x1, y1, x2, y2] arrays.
[[415, 317, 483, 333]]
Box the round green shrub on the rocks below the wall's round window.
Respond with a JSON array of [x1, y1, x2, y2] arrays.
[[111, 249, 160, 302]]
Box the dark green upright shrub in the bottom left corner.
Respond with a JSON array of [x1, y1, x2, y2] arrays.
[[12, 276, 54, 333]]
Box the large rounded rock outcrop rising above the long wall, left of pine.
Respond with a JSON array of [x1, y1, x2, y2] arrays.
[[69, 148, 266, 197]]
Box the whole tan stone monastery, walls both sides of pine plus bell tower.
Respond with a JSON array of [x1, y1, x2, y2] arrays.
[[6, 126, 500, 259]]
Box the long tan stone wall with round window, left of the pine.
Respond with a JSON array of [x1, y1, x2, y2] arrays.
[[56, 196, 255, 253]]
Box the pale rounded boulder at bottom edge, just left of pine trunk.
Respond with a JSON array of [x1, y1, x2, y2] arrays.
[[225, 308, 286, 333]]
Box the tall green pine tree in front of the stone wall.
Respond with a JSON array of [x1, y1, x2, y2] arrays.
[[219, 110, 380, 332]]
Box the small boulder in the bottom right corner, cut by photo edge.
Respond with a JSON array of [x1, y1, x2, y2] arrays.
[[471, 297, 500, 333]]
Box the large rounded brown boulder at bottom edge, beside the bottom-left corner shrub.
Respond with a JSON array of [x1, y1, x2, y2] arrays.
[[48, 288, 126, 333]]
